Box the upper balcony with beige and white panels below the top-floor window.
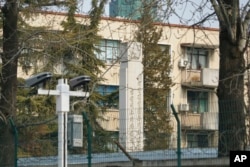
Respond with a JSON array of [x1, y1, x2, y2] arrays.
[[181, 68, 219, 88]]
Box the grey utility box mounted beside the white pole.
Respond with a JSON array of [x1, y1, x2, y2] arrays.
[[67, 115, 83, 147]]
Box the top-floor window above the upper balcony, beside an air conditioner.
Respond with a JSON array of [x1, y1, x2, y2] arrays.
[[186, 47, 208, 70]]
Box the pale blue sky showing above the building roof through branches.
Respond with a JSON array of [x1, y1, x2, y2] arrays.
[[47, 0, 250, 28]]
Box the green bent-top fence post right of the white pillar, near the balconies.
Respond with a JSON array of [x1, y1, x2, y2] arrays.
[[171, 104, 181, 167]]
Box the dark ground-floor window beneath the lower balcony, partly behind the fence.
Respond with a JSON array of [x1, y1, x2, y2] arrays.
[[187, 133, 208, 148]]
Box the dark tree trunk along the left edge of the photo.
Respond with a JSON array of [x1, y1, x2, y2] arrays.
[[0, 0, 18, 167]]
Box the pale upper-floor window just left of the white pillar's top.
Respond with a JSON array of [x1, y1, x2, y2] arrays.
[[97, 39, 120, 63]]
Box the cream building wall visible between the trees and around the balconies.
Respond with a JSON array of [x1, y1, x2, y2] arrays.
[[19, 13, 219, 147]]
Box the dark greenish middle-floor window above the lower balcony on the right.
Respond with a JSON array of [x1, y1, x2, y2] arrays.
[[187, 91, 208, 113]]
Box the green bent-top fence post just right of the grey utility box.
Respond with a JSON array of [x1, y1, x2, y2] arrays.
[[82, 112, 92, 167]]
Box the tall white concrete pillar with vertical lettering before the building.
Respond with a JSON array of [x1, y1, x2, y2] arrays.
[[119, 42, 143, 152]]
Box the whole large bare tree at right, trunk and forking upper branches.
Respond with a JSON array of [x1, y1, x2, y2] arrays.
[[210, 0, 250, 156]]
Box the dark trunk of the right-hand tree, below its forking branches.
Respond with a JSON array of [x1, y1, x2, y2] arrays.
[[217, 26, 246, 156]]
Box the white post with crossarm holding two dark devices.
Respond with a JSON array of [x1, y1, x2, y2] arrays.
[[38, 79, 89, 167]]
